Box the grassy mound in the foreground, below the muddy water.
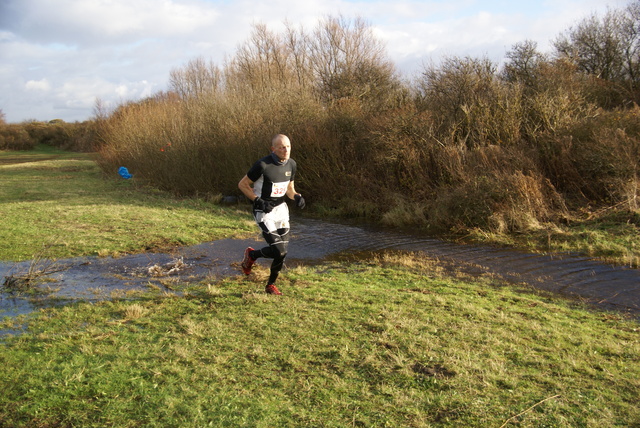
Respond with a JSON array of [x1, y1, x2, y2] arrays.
[[0, 254, 640, 427]]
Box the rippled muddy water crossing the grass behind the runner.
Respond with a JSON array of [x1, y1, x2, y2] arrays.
[[0, 218, 640, 317]]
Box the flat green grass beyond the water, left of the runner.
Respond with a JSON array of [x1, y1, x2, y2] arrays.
[[0, 146, 254, 261]]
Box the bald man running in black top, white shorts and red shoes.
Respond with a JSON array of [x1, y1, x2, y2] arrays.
[[238, 134, 305, 295]]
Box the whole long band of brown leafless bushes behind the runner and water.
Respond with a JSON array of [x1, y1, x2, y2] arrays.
[[94, 10, 640, 232]]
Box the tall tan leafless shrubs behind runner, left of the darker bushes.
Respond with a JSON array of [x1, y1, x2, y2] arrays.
[[99, 18, 403, 199]]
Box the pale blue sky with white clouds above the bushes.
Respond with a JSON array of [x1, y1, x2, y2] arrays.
[[0, 0, 631, 123]]
